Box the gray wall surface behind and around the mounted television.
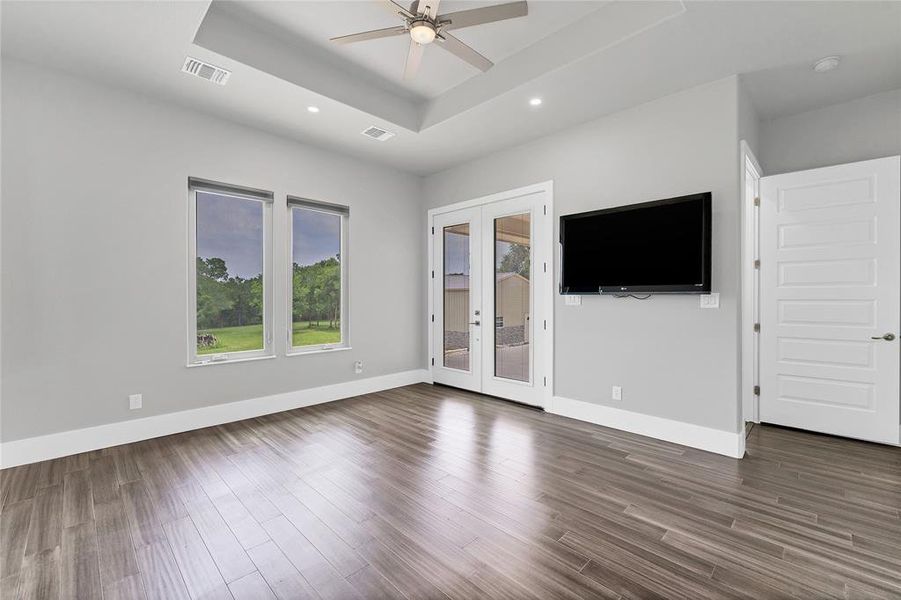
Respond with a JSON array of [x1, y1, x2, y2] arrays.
[[425, 77, 740, 431]]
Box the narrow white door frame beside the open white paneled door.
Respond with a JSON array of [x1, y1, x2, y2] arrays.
[[739, 140, 763, 424]]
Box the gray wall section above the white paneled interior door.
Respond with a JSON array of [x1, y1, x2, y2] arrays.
[[757, 90, 901, 175]]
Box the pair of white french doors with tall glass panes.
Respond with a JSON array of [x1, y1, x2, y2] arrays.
[[431, 191, 553, 406]]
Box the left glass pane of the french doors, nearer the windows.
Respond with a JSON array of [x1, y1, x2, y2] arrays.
[[443, 223, 470, 371]]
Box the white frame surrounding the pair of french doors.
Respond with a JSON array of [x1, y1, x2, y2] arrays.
[[425, 180, 557, 409]]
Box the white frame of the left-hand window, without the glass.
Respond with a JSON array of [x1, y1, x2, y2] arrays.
[[187, 177, 275, 367]]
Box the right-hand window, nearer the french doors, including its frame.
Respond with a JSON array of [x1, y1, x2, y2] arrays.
[[288, 197, 350, 352]]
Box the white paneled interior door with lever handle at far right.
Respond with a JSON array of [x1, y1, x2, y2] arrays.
[[760, 156, 901, 444]]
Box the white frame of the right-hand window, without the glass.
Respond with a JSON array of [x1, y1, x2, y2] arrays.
[[285, 196, 351, 356]]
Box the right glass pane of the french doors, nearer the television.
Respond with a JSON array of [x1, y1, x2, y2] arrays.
[[494, 213, 532, 382]]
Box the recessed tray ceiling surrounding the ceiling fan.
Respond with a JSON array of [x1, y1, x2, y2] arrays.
[[194, 0, 685, 131]]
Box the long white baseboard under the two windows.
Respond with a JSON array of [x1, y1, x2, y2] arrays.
[[0, 369, 431, 469]]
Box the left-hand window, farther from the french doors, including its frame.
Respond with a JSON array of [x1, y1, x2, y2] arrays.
[[188, 178, 272, 364]]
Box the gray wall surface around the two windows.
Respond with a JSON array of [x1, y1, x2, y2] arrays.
[[0, 60, 425, 441]]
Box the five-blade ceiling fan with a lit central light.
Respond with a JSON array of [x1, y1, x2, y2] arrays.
[[331, 0, 529, 79]]
